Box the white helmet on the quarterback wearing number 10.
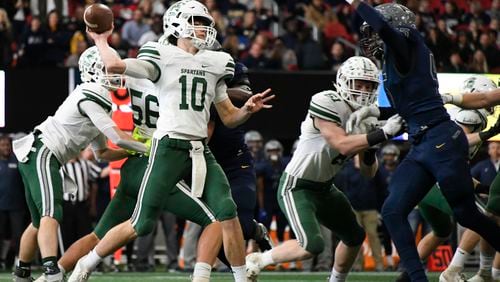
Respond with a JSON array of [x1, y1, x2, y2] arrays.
[[163, 0, 217, 49]]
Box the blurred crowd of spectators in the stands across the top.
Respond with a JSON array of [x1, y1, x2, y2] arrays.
[[0, 0, 500, 73]]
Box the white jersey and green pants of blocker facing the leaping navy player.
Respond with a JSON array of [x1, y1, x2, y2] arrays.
[[278, 91, 365, 254]]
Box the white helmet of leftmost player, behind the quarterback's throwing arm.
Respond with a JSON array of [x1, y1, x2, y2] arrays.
[[78, 46, 124, 90]]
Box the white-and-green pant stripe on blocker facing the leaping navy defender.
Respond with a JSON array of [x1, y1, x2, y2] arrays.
[[281, 174, 307, 248]]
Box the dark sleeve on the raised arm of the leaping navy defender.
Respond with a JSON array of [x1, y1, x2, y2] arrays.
[[356, 2, 411, 66]]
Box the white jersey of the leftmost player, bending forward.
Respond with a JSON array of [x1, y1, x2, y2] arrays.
[[35, 83, 112, 163]]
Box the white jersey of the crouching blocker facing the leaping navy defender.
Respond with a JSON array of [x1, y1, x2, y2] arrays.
[[285, 90, 352, 182]]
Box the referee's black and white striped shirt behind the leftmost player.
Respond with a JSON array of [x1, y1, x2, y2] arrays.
[[63, 159, 101, 202]]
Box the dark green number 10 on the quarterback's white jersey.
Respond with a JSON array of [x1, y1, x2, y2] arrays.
[[179, 75, 207, 112]]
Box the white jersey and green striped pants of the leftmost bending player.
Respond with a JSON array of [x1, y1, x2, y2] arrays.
[[14, 83, 113, 227]]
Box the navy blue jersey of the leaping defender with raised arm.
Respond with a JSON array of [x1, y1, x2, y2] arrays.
[[357, 3, 449, 134]]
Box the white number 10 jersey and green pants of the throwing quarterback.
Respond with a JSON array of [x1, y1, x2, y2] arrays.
[[131, 42, 236, 235]]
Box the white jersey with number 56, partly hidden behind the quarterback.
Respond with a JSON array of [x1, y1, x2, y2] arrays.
[[125, 76, 160, 138]]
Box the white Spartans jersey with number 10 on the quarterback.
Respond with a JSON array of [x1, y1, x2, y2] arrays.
[[137, 42, 234, 140]]
